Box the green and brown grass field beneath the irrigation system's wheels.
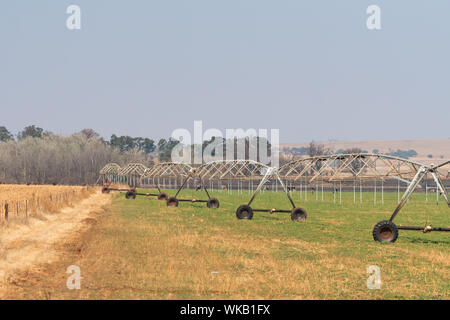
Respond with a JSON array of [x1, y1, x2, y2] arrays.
[[4, 190, 450, 299]]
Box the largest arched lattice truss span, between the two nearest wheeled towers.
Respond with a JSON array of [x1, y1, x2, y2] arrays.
[[279, 153, 423, 183]]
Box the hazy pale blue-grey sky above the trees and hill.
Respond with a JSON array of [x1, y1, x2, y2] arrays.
[[0, 0, 450, 143]]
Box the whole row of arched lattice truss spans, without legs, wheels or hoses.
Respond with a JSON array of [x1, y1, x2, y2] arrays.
[[100, 153, 450, 183]]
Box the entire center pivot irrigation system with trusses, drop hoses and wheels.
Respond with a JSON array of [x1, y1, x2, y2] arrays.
[[99, 153, 450, 242]]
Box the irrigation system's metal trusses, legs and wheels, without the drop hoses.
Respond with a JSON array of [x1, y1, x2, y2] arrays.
[[99, 153, 450, 242]]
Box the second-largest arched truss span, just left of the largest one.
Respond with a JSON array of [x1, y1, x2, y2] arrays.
[[195, 160, 269, 180]]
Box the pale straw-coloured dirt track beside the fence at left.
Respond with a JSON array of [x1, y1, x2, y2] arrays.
[[0, 192, 111, 298]]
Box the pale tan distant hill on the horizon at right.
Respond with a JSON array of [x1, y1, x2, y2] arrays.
[[280, 138, 450, 164]]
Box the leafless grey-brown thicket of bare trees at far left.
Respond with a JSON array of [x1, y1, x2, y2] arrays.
[[0, 134, 152, 184]]
